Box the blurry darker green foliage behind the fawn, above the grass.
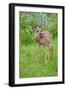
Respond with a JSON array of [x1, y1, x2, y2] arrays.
[[20, 12, 58, 45]]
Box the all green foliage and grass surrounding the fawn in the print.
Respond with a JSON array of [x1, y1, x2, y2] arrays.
[[19, 12, 58, 78]]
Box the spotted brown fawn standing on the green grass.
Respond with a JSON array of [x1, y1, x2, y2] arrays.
[[34, 26, 53, 64]]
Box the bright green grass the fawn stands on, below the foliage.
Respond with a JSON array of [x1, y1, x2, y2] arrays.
[[19, 38, 58, 78]]
